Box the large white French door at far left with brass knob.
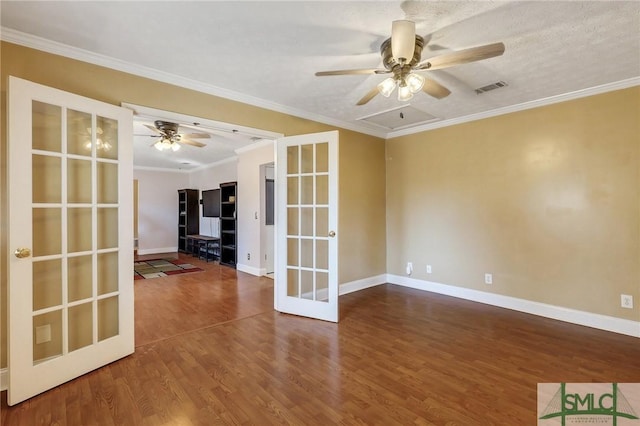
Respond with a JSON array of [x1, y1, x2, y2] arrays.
[[8, 77, 134, 405]]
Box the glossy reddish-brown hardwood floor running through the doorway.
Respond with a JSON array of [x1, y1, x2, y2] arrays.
[[0, 251, 640, 426]]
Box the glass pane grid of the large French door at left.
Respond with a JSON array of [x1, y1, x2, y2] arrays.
[[32, 101, 118, 365]]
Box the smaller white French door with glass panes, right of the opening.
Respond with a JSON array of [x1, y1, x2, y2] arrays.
[[275, 131, 338, 322]]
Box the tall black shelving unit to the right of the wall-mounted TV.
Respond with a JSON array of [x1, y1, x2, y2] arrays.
[[220, 182, 238, 268]]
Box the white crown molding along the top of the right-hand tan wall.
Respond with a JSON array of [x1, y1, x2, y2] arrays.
[[387, 77, 640, 139]]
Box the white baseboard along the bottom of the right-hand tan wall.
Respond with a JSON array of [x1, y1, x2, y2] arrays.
[[387, 274, 640, 338]]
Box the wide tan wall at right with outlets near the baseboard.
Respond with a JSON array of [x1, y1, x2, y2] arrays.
[[387, 87, 640, 321]]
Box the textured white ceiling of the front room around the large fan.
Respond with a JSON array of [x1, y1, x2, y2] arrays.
[[0, 1, 640, 171]]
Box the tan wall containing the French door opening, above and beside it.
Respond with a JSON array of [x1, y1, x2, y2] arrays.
[[0, 42, 386, 367]]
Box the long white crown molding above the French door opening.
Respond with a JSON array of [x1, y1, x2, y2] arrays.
[[0, 27, 386, 138]]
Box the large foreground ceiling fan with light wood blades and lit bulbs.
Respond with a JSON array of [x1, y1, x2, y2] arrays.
[[316, 20, 504, 105]]
